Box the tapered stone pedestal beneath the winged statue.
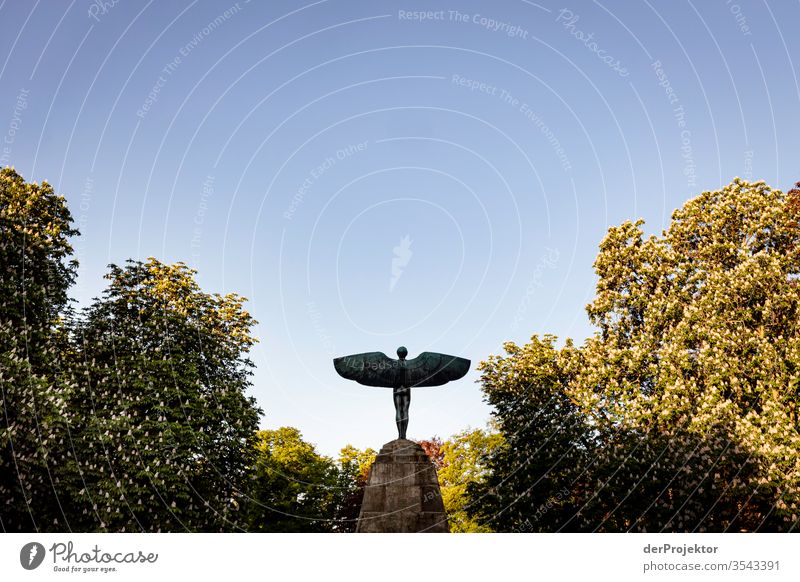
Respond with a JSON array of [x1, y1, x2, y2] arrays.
[[356, 439, 450, 533]]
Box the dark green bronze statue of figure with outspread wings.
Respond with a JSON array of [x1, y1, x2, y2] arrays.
[[333, 346, 470, 439]]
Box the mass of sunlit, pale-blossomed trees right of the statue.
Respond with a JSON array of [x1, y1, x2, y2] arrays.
[[472, 179, 800, 531]]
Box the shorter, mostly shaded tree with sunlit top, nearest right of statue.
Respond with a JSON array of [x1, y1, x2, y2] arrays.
[[465, 335, 596, 532]]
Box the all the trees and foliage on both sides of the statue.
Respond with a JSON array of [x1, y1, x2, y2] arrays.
[[6, 168, 800, 532]]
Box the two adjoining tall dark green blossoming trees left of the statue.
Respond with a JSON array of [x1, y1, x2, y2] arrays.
[[0, 168, 260, 531]]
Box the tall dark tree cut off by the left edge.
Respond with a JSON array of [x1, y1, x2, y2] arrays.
[[0, 168, 78, 531]]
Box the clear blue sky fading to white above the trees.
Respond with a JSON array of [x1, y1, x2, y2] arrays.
[[0, 0, 800, 456]]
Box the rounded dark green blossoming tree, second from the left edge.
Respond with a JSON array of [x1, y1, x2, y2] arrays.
[[65, 258, 260, 531]]
